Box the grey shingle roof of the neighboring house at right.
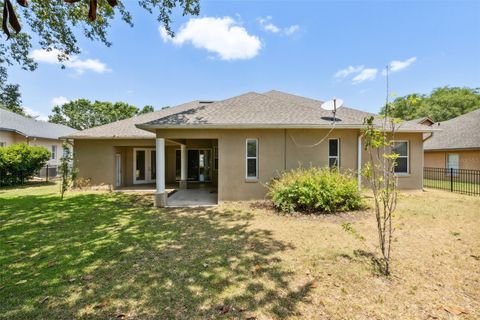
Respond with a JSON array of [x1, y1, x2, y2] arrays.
[[424, 109, 480, 150]]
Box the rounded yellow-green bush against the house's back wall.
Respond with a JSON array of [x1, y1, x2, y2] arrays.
[[268, 167, 363, 213]]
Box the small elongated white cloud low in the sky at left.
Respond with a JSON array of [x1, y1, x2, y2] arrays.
[[30, 49, 110, 74]]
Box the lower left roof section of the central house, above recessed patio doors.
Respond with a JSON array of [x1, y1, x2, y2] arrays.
[[67, 101, 203, 139]]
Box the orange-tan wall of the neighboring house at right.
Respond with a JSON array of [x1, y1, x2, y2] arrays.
[[425, 150, 480, 170]]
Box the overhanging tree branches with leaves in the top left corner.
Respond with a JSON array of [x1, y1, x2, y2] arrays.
[[0, 0, 200, 74]]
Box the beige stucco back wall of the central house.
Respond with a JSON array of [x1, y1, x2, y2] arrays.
[[75, 129, 423, 200]]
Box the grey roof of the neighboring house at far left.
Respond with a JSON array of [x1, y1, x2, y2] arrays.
[[0, 108, 77, 139]]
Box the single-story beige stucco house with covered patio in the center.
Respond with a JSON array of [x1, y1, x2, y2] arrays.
[[68, 91, 433, 206]]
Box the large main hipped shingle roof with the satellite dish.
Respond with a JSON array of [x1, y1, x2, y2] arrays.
[[136, 91, 431, 132]]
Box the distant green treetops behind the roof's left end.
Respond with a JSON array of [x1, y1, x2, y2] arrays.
[[48, 99, 153, 130]]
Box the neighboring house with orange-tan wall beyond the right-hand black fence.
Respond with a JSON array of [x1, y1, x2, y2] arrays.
[[424, 109, 480, 170]]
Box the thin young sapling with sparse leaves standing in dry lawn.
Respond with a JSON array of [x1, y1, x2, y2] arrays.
[[362, 116, 398, 275]]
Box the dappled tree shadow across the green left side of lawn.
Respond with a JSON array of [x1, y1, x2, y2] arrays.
[[0, 193, 310, 319]]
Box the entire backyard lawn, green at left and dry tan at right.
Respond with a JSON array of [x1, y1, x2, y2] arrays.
[[0, 185, 480, 319]]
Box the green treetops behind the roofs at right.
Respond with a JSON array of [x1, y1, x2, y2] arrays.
[[381, 87, 480, 122]]
